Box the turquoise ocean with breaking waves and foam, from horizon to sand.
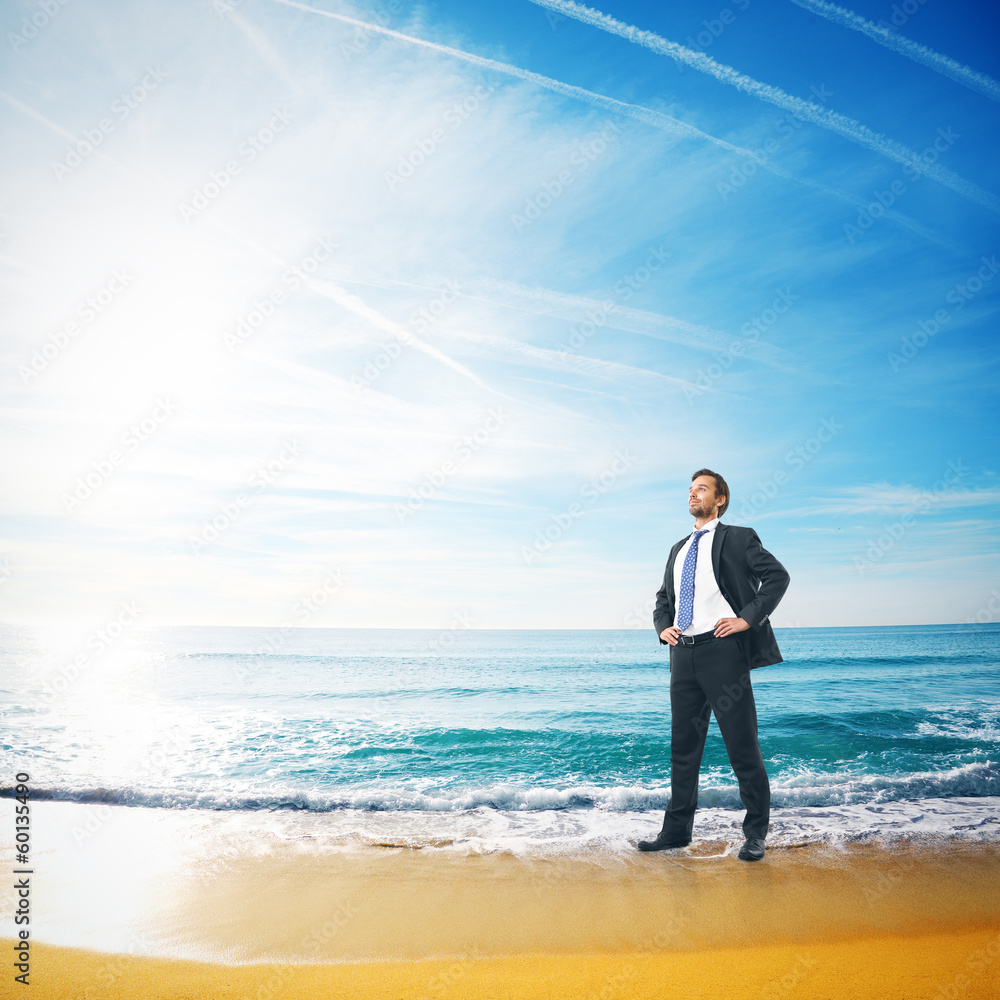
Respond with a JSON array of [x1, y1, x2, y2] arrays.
[[0, 615, 1000, 851]]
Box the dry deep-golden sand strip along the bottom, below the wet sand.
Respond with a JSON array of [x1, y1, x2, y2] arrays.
[[11, 928, 1000, 1000]]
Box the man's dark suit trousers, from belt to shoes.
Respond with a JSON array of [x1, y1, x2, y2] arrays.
[[663, 635, 771, 840]]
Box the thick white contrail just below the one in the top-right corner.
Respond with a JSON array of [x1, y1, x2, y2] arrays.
[[524, 0, 1000, 215]]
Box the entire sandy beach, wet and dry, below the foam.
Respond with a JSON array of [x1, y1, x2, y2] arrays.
[[0, 804, 1000, 1000]]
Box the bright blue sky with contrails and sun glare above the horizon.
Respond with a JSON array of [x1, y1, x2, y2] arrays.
[[0, 0, 1000, 628]]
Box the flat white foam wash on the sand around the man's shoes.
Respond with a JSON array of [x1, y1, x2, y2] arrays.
[[13, 796, 1000, 856]]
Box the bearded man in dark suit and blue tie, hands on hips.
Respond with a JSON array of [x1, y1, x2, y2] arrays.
[[638, 469, 788, 861]]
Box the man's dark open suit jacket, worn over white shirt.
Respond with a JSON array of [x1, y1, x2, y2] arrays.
[[653, 523, 788, 670]]
